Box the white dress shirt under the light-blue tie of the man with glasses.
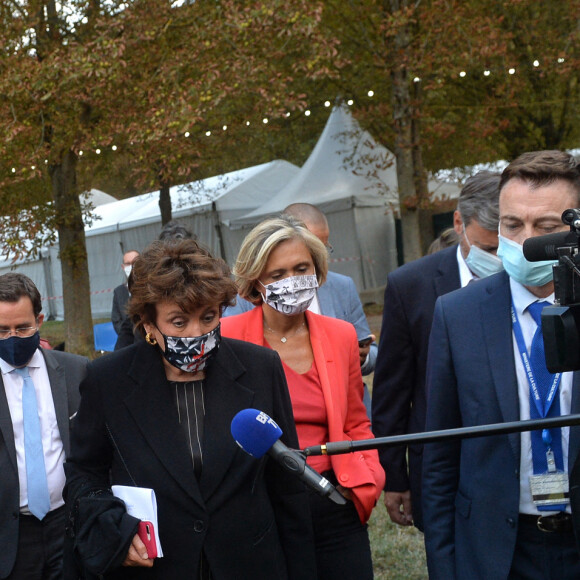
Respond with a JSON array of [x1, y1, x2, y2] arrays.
[[0, 349, 65, 514]]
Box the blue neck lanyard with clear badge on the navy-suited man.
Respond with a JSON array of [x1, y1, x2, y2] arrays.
[[511, 304, 570, 509]]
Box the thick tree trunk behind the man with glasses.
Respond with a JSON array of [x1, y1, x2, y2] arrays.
[[50, 150, 94, 355]]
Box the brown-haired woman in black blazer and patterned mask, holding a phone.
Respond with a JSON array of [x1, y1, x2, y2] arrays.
[[65, 240, 316, 580]]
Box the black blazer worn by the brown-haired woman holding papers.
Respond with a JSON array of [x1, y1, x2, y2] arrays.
[[65, 338, 316, 580]]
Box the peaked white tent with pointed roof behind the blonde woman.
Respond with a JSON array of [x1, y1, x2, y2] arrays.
[[229, 104, 458, 292]]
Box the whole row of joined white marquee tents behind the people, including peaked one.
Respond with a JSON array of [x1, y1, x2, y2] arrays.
[[0, 105, 459, 319]]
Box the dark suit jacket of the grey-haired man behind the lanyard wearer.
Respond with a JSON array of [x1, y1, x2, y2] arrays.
[[372, 246, 461, 529]]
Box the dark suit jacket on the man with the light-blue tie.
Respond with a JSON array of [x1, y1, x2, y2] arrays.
[[0, 349, 88, 578]]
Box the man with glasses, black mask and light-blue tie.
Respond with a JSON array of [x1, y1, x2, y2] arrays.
[[0, 272, 88, 580]]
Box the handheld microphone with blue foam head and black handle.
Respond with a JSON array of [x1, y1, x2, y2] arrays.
[[231, 409, 346, 505]]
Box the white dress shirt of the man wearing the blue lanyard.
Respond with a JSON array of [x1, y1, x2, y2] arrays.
[[510, 278, 572, 515]]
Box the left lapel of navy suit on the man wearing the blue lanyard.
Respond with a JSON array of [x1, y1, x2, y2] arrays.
[[477, 274, 520, 461]]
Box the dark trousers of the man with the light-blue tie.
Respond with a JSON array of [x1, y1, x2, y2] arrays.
[[6, 506, 66, 580]]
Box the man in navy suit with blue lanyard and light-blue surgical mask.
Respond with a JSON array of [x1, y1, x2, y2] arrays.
[[423, 151, 580, 580]]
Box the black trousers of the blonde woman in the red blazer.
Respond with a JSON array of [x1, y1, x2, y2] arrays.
[[309, 472, 373, 580]]
